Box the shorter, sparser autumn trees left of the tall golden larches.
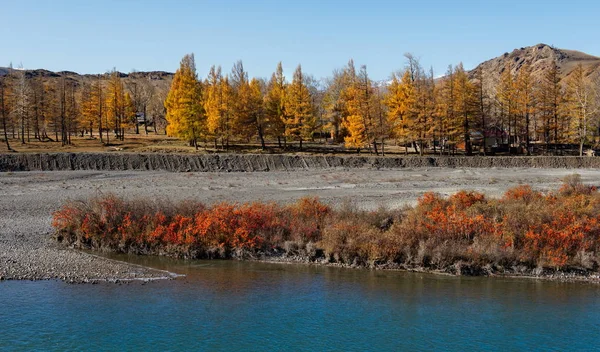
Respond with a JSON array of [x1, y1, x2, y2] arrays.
[[0, 69, 167, 150]]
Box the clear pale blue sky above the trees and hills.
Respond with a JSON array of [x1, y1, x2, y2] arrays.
[[0, 0, 600, 80]]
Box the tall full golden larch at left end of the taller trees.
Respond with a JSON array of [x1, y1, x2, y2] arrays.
[[165, 54, 206, 149]]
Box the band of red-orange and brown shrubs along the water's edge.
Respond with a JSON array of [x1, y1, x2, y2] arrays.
[[52, 175, 600, 275]]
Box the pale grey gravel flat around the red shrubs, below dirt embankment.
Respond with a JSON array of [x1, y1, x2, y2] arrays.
[[0, 168, 600, 281]]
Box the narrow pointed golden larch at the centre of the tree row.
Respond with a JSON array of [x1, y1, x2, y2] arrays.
[[284, 65, 315, 150]]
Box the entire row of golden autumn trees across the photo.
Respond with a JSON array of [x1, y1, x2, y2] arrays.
[[0, 54, 600, 155]]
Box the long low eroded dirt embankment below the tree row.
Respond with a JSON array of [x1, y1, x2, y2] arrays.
[[0, 153, 600, 172]]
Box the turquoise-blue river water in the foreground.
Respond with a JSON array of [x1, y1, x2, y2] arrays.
[[0, 258, 600, 351]]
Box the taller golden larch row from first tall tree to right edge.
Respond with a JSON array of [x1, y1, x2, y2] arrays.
[[165, 54, 600, 155]]
